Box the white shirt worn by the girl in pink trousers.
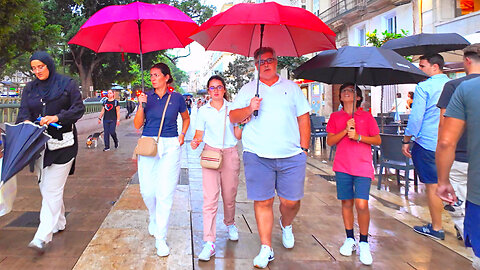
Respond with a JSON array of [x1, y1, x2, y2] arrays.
[[196, 99, 238, 148]]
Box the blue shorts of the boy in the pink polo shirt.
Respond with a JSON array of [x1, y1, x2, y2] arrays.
[[335, 172, 372, 201]]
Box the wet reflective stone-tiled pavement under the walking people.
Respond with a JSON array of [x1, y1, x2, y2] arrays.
[[0, 113, 471, 269]]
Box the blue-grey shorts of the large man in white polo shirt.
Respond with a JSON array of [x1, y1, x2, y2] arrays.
[[243, 152, 307, 201]]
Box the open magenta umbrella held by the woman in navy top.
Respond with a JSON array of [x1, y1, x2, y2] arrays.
[[68, 2, 198, 91]]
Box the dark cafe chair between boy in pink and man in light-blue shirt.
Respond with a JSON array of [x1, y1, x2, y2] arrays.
[[377, 134, 418, 196]]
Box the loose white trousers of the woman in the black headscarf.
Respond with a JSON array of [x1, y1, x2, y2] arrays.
[[34, 157, 74, 243]]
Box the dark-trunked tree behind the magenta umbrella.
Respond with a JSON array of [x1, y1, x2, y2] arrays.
[[44, 0, 213, 96]]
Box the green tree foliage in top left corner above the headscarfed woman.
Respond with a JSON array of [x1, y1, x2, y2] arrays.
[[0, 0, 61, 75]]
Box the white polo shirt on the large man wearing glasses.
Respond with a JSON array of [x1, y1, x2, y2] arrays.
[[231, 75, 311, 158]]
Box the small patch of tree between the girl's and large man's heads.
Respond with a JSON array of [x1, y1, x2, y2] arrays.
[[223, 55, 254, 93]]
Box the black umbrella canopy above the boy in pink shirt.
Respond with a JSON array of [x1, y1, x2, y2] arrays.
[[294, 46, 428, 86]]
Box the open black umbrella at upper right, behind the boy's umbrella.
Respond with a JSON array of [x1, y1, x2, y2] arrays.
[[382, 33, 470, 55]]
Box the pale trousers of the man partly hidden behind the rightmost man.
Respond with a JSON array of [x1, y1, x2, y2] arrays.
[[449, 161, 468, 234]]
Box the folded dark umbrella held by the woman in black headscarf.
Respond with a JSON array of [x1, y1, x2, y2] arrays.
[[0, 123, 50, 182]]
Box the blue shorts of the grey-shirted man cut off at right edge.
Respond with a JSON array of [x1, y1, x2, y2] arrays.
[[463, 200, 480, 257]]
